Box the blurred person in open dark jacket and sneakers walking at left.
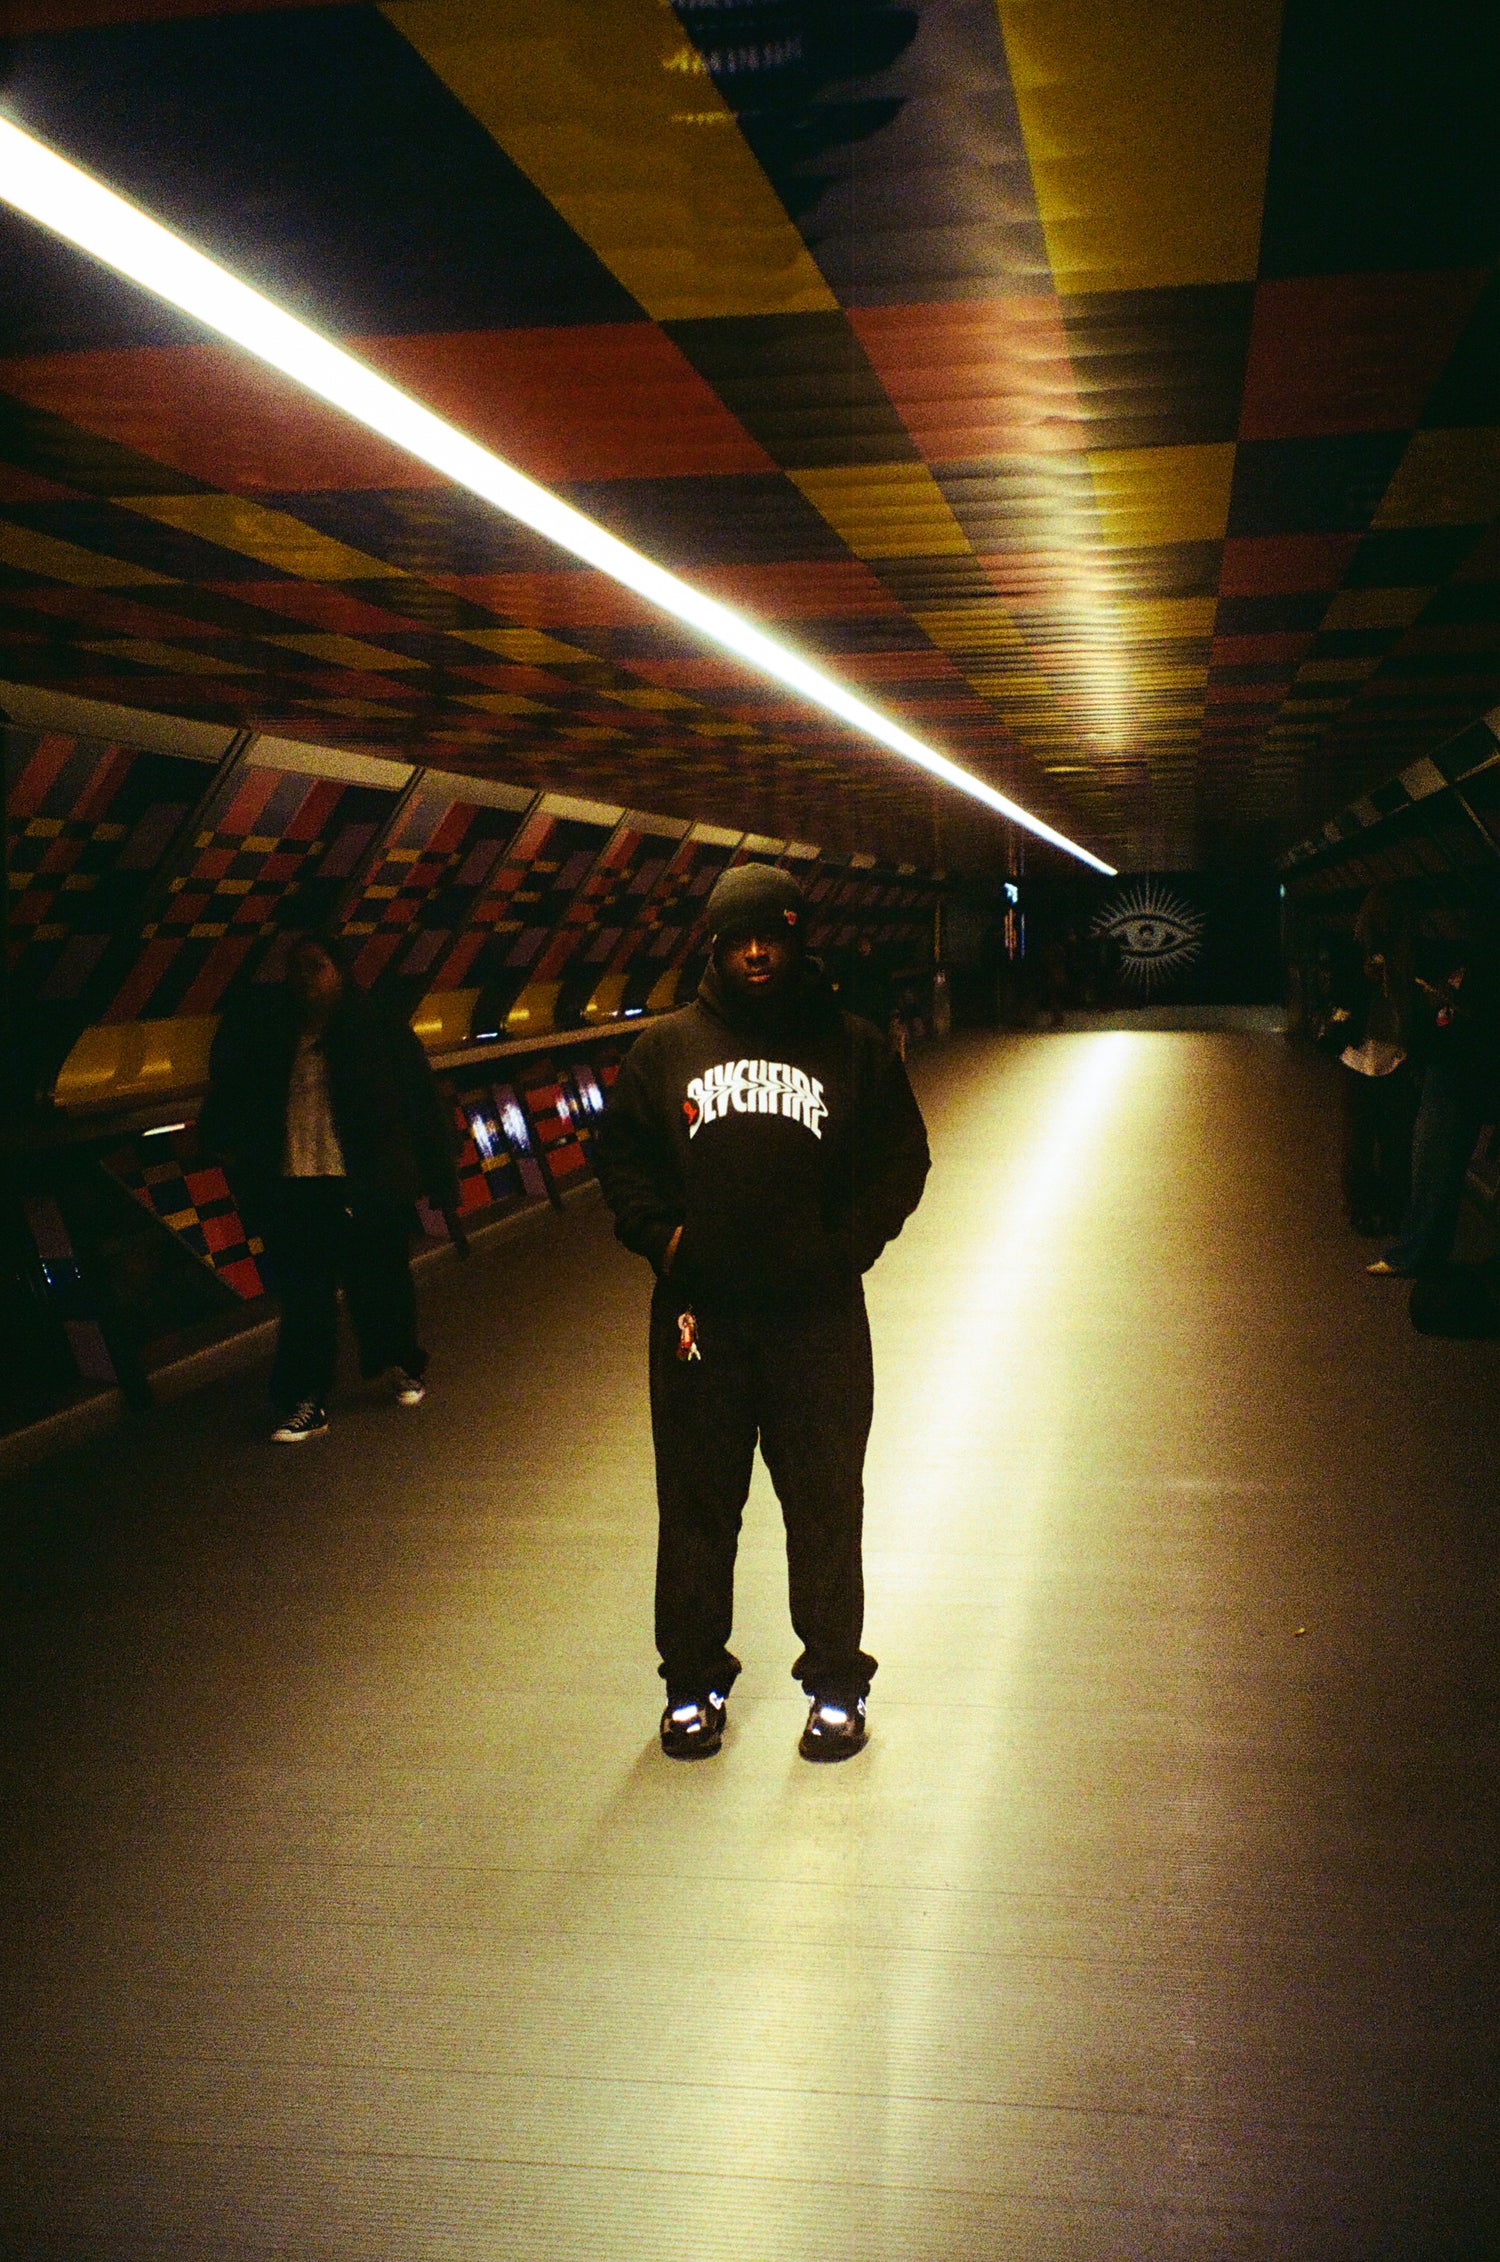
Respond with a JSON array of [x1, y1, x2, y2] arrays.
[[199, 934, 459, 1445]]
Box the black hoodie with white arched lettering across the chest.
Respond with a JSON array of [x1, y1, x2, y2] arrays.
[[597, 964, 928, 1305]]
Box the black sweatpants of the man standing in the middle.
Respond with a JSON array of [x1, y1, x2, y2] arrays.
[[652, 1280, 876, 1703]]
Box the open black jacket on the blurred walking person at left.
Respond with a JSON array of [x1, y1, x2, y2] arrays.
[[199, 984, 459, 1224]]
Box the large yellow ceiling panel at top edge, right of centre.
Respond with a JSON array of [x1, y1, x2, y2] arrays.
[[995, 0, 1281, 292]]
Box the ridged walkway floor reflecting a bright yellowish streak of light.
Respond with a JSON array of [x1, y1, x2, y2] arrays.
[[0, 1034, 1500, 2262]]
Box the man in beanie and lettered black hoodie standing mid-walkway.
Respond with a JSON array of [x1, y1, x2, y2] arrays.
[[597, 864, 928, 1760]]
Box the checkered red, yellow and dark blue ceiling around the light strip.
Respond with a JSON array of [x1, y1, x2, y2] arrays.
[[0, 0, 1500, 866]]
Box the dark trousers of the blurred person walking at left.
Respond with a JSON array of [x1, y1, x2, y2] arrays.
[[265, 1179, 428, 1411]]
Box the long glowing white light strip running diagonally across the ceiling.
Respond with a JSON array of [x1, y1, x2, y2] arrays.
[[0, 118, 1115, 878]]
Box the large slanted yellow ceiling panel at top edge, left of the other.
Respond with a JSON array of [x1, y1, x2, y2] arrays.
[[382, 0, 837, 321]]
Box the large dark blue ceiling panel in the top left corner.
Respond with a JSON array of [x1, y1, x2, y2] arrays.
[[5, 7, 640, 346]]
